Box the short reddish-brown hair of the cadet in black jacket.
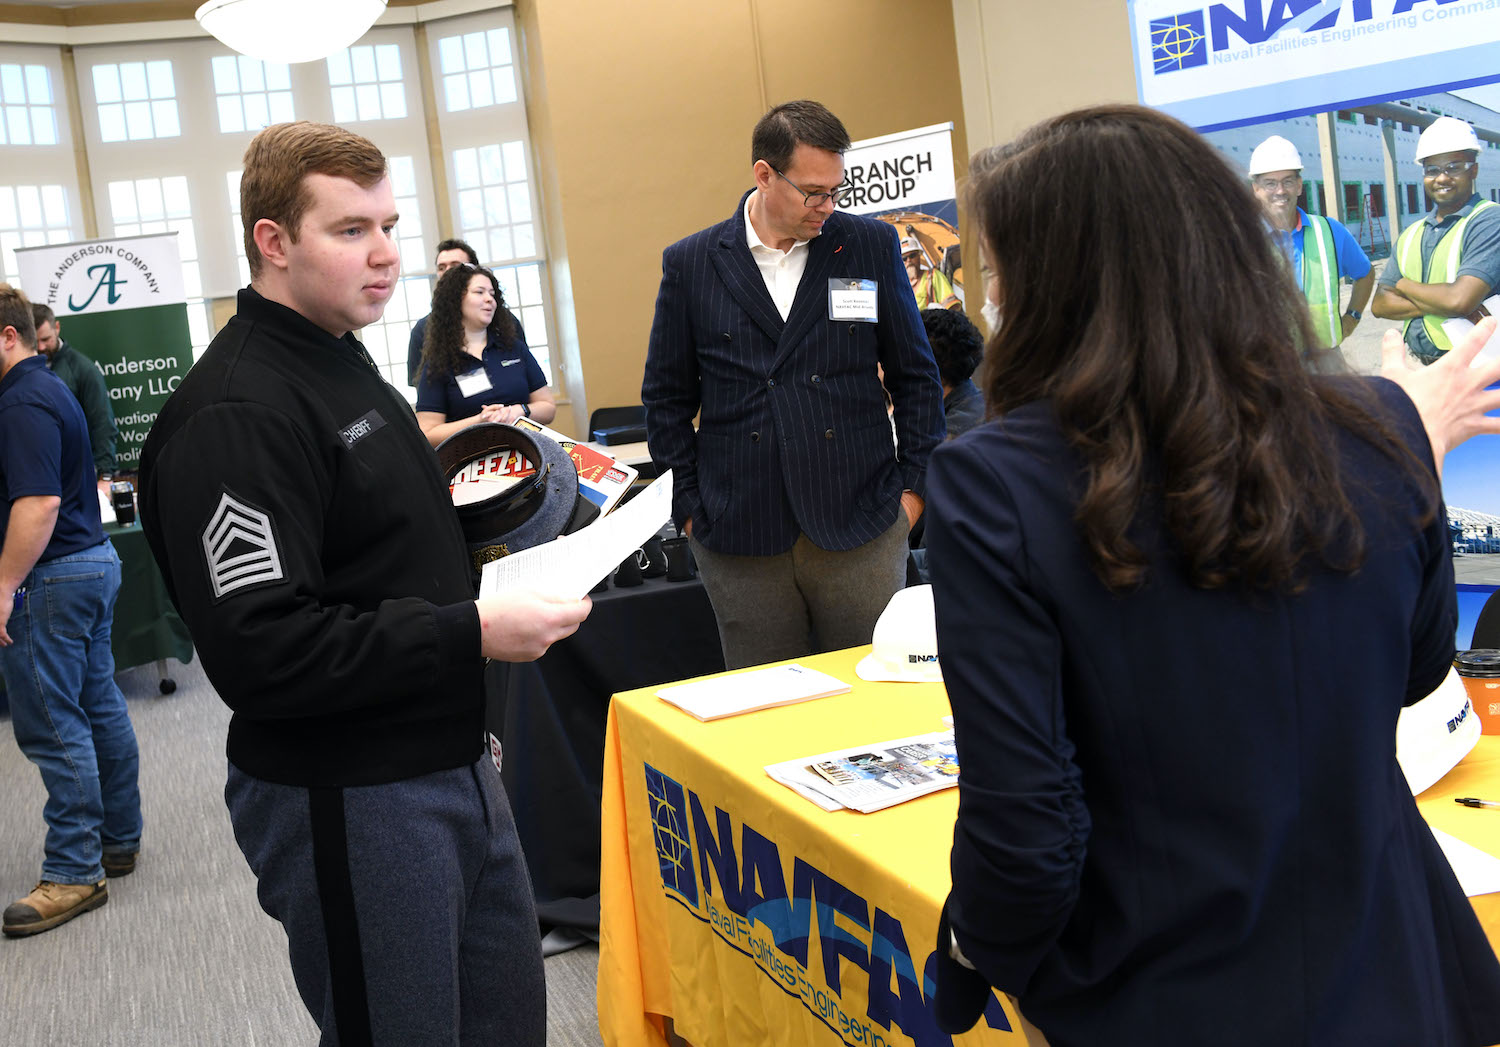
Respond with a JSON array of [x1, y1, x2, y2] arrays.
[[240, 120, 386, 281]]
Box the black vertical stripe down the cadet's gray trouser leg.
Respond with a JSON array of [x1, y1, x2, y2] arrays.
[[308, 788, 374, 1047]]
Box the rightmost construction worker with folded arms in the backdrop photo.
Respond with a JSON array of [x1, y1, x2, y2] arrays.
[[1374, 117, 1500, 363]]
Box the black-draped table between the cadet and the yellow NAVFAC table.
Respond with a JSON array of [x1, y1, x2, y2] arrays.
[[486, 578, 725, 930]]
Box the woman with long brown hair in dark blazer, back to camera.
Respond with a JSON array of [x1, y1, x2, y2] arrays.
[[927, 107, 1500, 1047]]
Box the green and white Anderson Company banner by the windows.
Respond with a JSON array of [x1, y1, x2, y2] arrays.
[[15, 233, 192, 473]]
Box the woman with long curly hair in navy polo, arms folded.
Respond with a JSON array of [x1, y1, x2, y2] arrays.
[[417, 266, 558, 447]]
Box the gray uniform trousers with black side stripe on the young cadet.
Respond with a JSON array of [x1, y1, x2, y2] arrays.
[[224, 758, 546, 1047]]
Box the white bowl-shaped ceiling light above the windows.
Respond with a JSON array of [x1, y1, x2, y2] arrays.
[[195, 0, 386, 63]]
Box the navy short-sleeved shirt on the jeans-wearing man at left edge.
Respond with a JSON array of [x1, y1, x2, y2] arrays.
[[0, 356, 104, 563]]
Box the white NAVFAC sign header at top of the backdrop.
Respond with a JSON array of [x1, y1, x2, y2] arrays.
[[1128, 0, 1500, 131]]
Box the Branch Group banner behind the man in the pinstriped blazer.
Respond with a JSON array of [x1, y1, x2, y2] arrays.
[[842, 123, 963, 305]]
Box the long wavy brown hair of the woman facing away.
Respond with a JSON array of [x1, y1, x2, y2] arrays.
[[969, 105, 1437, 591]]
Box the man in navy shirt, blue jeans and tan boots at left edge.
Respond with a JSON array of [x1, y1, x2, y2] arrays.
[[0, 284, 141, 938]]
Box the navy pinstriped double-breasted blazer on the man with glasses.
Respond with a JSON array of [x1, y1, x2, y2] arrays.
[[641, 191, 944, 557]]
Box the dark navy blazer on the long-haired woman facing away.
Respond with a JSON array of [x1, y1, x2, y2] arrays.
[[927, 380, 1500, 1047]]
